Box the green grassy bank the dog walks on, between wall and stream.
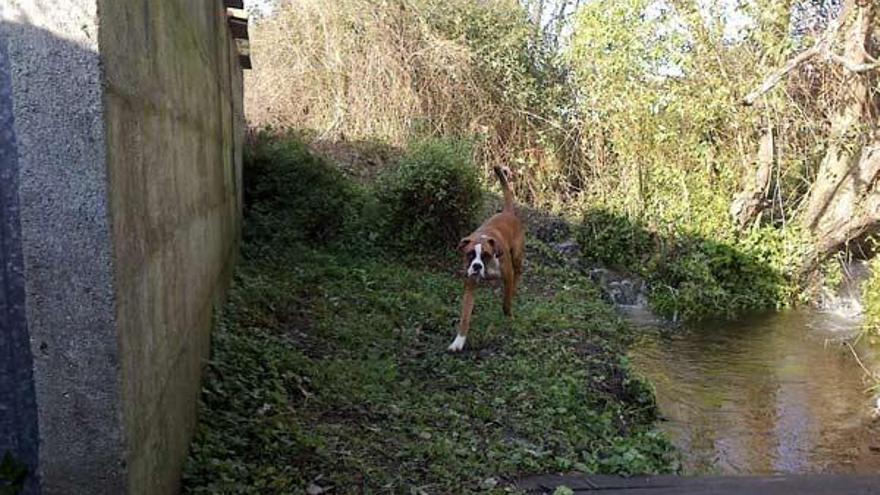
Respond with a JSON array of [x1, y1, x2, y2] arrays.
[[184, 135, 676, 493]]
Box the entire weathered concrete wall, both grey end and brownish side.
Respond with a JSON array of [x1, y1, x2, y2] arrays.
[[0, 0, 243, 494]]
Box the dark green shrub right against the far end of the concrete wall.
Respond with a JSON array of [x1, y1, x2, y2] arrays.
[[243, 132, 359, 247]]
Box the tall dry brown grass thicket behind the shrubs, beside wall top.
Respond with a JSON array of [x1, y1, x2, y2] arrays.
[[246, 0, 496, 145]]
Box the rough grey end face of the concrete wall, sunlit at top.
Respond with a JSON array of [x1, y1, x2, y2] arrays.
[[2, 0, 125, 493]]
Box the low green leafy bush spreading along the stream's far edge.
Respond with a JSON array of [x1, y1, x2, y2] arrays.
[[578, 210, 796, 319]]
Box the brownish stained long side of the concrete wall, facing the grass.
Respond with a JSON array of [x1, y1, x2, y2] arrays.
[[98, 0, 242, 493]]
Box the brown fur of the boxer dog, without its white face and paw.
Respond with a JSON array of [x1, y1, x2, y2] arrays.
[[450, 167, 525, 350]]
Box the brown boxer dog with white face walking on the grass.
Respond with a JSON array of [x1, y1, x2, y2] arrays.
[[449, 166, 525, 352]]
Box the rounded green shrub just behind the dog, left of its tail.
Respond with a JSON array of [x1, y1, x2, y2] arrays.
[[378, 139, 482, 248]]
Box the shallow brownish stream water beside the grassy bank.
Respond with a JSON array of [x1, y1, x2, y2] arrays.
[[630, 311, 880, 475]]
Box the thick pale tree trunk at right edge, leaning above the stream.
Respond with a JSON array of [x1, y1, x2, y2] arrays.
[[802, 0, 880, 266]]
